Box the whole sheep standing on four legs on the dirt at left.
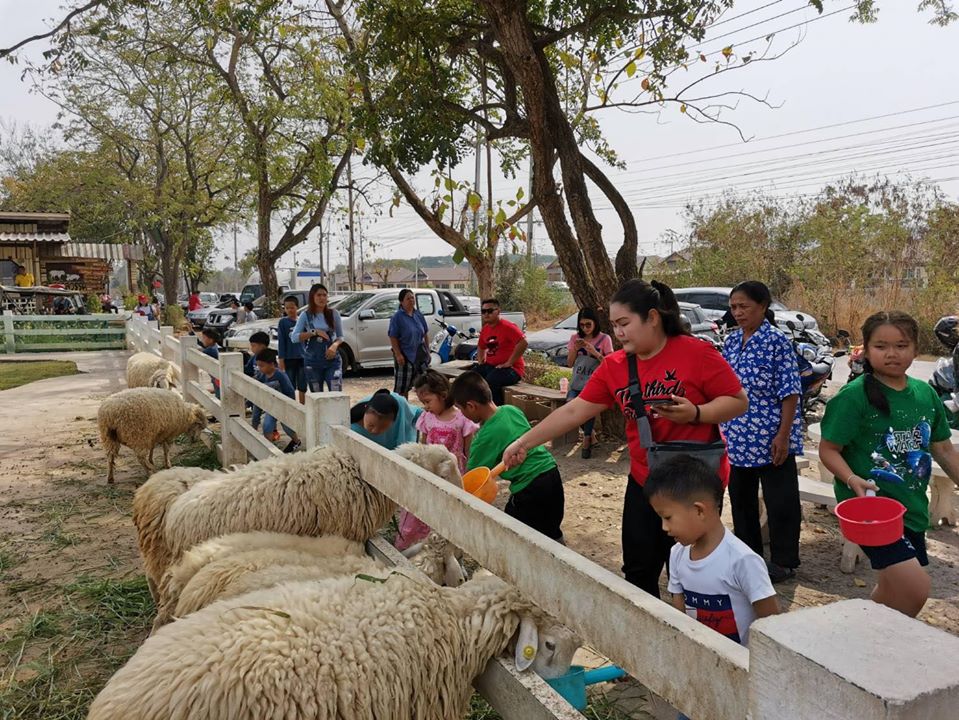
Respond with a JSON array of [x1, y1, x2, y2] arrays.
[[97, 387, 206, 484]]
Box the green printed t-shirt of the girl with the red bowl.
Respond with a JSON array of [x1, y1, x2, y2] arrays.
[[822, 376, 951, 532]]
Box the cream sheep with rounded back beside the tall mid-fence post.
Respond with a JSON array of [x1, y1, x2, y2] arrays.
[[138, 443, 459, 587]]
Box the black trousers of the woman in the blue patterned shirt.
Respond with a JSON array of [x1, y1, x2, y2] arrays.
[[729, 455, 802, 568]]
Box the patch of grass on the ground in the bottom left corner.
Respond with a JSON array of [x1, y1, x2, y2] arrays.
[[0, 576, 154, 720]]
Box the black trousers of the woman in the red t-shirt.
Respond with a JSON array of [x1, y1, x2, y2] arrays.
[[623, 476, 676, 598]]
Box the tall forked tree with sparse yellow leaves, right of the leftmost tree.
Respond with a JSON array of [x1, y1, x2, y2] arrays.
[[153, 0, 354, 309]]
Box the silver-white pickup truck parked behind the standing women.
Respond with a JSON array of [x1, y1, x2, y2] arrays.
[[223, 288, 526, 370]]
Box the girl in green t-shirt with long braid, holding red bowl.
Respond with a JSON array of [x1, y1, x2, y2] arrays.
[[819, 311, 959, 617]]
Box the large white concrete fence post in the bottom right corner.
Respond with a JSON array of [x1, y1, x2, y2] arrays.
[[749, 600, 959, 720]]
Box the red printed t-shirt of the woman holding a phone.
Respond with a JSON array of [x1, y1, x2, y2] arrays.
[[579, 335, 742, 485]]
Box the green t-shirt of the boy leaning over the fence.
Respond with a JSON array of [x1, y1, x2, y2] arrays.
[[466, 405, 556, 495]]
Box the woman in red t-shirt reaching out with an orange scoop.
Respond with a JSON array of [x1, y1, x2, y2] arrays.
[[503, 280, 748, 597]]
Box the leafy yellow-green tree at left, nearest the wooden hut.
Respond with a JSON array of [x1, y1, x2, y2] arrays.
[[36, 18, 244, 310]]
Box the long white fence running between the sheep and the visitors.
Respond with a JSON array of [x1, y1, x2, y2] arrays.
[[128, 317, 959, 720]]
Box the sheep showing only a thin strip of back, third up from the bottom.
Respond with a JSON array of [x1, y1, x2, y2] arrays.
[[152, 532, 366, 631]]
